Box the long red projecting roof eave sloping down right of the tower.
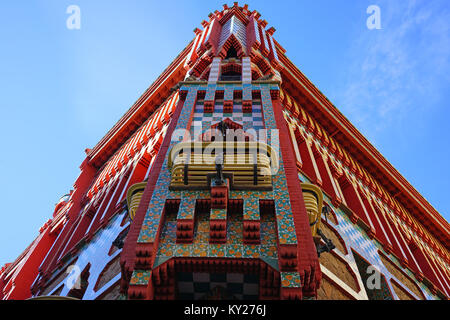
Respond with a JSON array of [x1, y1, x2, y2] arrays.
[[276, 43, 450, 249]]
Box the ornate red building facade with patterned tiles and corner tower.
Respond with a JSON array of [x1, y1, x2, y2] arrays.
[[0, 3, 450, 300]]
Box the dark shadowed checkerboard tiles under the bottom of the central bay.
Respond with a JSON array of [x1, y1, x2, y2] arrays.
[[176, 273, 259, 300]]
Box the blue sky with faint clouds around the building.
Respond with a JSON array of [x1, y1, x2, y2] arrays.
[[0, 0, 450, 265]]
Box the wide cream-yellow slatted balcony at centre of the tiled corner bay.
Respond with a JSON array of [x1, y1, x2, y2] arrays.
[[168, 141, 279, 190]]
